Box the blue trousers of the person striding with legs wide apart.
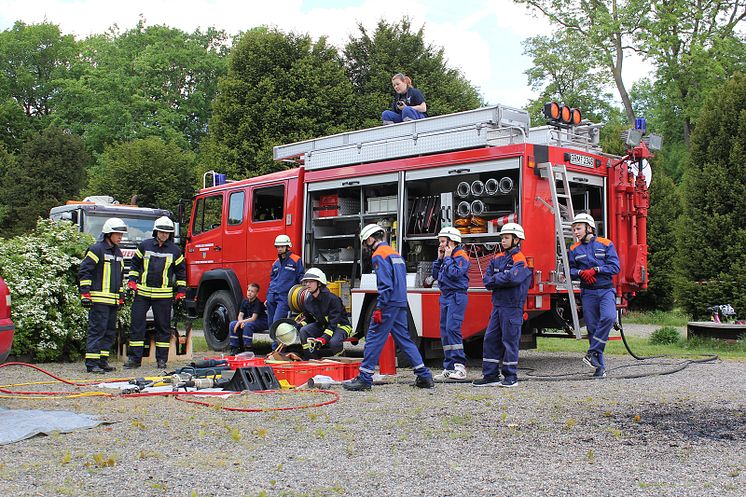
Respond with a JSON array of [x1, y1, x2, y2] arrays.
[[359, 307, 433, 385]]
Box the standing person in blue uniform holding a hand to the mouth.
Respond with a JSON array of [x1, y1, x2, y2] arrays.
[[433, 227, 469, 381]]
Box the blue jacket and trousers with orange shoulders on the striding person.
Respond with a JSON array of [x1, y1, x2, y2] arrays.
[[359, 243, 433, 385]]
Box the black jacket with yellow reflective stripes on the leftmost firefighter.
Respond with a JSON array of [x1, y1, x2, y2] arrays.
[[78, 240, 124, 305]]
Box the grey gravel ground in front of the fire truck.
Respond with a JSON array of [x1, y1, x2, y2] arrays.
[[0, 352, 746, 496]]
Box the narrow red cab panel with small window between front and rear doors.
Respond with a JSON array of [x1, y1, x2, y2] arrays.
[[222, 189, 249, 290]]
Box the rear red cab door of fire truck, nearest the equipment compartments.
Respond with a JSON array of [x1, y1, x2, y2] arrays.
[[247, 181, 288, 298]]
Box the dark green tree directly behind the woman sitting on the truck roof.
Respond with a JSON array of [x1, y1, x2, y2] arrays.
[[343, 17, 482, 127]]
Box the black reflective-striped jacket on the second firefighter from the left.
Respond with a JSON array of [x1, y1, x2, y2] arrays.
[[129, 238, 186, 299]]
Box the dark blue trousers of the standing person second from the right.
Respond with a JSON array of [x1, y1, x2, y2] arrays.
[[482, 306, 523, 379]]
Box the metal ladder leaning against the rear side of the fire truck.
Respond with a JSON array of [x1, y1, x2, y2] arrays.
[[536, 162, 582, 339]]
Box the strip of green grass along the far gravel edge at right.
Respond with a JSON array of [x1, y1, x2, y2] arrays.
[[536, 332, 746, 360]]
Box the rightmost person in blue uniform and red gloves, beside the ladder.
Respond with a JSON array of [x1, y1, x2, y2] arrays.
[[567, 214, 619, 378]]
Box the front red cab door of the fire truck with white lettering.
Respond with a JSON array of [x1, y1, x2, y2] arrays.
[[186, 192, 223, 285]]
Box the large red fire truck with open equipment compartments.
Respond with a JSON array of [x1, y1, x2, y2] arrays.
[[186, 105, 649, 356]]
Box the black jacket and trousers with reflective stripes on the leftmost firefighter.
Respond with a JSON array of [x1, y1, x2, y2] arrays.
[[78, 240, 124, 368]]
